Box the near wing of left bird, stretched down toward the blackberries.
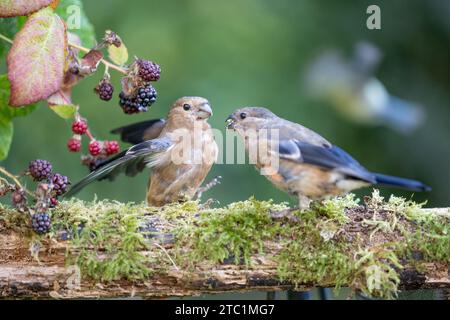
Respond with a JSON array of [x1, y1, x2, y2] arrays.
[[65, 138, 173, 197]]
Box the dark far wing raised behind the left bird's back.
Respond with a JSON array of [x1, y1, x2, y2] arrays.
[[111, 119, 166, 144]]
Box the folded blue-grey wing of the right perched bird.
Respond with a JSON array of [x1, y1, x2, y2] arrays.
[[279, 140, 376, 183]]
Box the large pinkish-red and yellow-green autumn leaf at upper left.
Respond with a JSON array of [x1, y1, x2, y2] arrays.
[[7, 8, 67, 107]]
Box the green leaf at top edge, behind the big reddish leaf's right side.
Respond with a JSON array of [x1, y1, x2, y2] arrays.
[[56, 0, 95, 48]]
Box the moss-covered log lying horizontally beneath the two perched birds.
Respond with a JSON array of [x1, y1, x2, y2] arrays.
[[0, 195, 450, 299]]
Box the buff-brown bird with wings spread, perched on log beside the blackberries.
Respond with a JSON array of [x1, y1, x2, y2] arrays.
[[66, 97, 218, 207]]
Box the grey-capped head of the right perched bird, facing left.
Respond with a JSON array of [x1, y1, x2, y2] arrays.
[[226, 107, 277, 131]]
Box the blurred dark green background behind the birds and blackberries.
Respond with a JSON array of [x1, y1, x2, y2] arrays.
[[1, 0, 450, 300]]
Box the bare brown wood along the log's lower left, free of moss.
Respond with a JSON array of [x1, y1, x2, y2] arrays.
[[0, 209, 450, 299]]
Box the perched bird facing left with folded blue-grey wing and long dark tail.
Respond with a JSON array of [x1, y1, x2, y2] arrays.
[[227, 107, 431, 209]]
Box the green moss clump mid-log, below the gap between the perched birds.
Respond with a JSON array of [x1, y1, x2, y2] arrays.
[[175, 199, 287, 266]]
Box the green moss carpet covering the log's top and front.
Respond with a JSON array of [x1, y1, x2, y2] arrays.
[[0, 190, 450, 299]]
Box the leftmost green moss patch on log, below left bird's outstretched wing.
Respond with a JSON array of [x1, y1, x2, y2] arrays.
[[52, 201, 151, 281]]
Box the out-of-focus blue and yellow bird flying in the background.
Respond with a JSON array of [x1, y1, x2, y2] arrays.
[[304, 42, 425, 134]]
